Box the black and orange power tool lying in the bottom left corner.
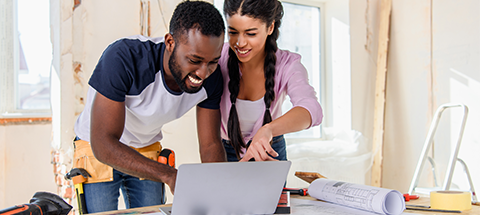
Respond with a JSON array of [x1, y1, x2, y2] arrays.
[[0, 192, 72, 215]]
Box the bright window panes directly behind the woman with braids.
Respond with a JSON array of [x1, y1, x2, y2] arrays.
[[214, 0, 323, 138]]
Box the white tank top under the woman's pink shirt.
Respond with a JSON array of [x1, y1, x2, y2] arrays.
[[235, 97, 265, 137]]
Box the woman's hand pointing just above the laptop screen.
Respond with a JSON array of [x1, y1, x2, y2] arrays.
[[240, 124, 278, 162]]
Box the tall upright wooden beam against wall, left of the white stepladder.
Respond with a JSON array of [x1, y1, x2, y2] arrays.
[[371, 0, 392, 187]]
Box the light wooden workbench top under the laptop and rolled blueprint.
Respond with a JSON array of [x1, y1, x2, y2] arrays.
[[89, 195, 480, 215]]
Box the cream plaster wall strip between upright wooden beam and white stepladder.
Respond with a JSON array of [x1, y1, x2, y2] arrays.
[[380, 0, 433, 192]]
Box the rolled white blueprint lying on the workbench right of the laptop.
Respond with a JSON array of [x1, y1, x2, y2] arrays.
[[308, 178, 405, 215]]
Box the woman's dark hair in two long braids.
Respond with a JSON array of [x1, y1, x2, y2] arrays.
[[223, 0, 283, 159]]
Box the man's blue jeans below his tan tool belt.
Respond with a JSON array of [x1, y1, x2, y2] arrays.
[[83, 169, 165, 213]]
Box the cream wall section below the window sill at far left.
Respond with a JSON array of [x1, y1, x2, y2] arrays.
[[0, 123, 57, 209]]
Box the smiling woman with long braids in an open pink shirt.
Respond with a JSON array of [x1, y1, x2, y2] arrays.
[[219, 0, 323, 161]]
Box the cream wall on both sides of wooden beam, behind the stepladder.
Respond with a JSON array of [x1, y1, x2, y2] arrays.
[[348, 0, 480, 192]]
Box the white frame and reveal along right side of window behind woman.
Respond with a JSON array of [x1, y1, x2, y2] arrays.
[[280, 0, 352, 134]]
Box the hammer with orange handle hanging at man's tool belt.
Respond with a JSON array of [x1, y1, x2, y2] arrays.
[[65, 168, 92, 214]]
